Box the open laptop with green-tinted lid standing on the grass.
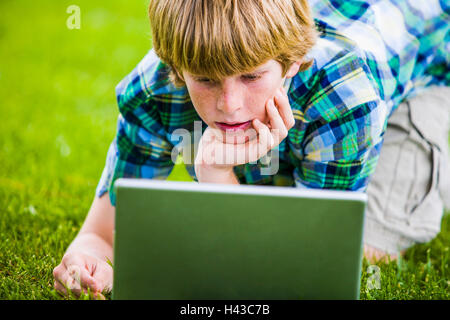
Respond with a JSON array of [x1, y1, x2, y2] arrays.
[[112, 178, 367, 300]]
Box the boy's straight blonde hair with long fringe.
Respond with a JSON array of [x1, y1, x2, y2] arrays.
[[149, 0, 317, 86]]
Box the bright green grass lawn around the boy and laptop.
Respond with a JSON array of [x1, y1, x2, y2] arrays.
[[0, 0, 450, 299]]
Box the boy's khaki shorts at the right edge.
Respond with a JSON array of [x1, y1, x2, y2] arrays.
[[364, 87, 450, 254]]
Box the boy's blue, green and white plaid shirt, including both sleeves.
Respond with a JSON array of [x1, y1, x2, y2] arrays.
[[96, 0, 450, 205]]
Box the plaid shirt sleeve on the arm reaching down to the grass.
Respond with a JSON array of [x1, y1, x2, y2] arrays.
[[96, 51, 174, 206]]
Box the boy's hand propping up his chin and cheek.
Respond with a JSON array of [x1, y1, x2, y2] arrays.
[[195, 88, 295, 182]]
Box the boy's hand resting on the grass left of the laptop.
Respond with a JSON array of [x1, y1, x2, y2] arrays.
[[53, 252, 113, 299]]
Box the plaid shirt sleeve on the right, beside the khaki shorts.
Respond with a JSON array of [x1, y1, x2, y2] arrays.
[[293, 55, 388, 191]]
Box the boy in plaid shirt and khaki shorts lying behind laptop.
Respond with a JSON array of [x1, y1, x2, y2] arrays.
[[54, 0, 449, 298]]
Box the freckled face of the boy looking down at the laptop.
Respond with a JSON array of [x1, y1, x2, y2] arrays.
[[182, 60, 301, 142]]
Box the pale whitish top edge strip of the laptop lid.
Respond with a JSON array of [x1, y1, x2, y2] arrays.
[[114, 178, 367, 202]]
